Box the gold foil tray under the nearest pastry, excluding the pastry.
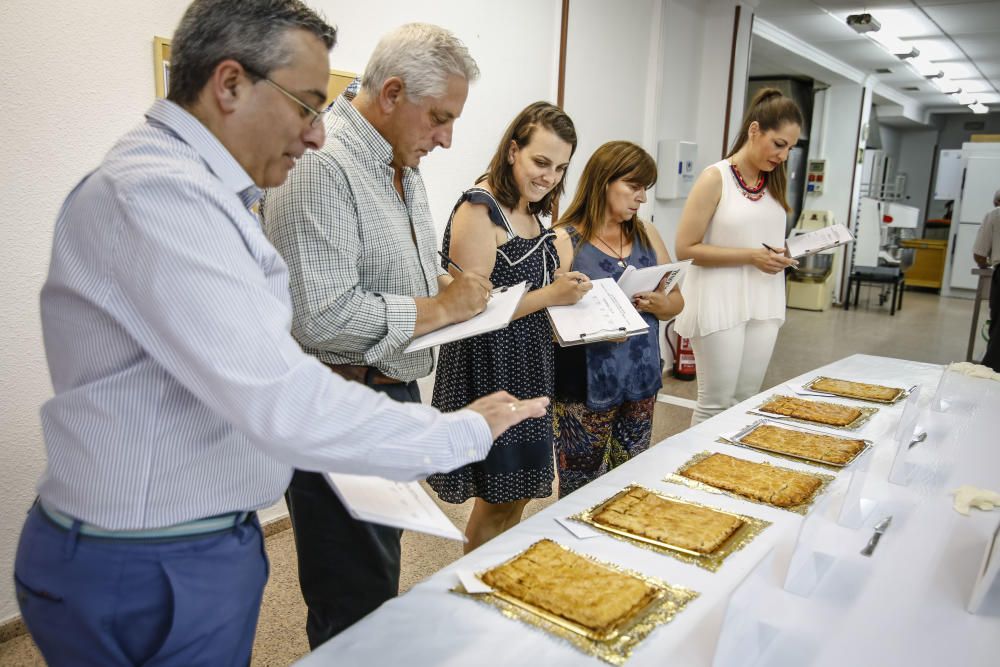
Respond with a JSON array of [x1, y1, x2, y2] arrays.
[[451, 544, 699, 665]]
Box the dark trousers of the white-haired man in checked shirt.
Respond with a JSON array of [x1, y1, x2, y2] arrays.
[[285, 382, 420, 649]]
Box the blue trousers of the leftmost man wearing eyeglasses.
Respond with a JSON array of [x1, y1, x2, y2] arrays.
[[14, 505, 268, 667]]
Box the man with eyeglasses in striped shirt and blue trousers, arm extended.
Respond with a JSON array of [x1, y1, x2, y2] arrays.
[[14, 0, 547, 666]]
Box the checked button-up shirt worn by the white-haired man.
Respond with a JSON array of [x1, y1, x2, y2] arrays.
[[263, 96, 444, 381]]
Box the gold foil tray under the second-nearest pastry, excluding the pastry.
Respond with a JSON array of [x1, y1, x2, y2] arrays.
[[570, 483, 771, 572]]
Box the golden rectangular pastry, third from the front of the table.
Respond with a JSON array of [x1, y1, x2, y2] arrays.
[[680, 453, 822, 507]]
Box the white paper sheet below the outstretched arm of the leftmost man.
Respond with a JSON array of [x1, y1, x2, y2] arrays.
[[326, 472, 465, 542]]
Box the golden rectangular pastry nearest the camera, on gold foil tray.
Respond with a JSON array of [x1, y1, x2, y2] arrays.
[[482, 540, 657, 636]]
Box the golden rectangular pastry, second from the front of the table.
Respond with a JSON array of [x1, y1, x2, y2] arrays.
[[594, 488, 743, 554]]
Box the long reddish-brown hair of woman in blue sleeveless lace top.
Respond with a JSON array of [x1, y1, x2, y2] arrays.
[[555, 141, 656, 247]]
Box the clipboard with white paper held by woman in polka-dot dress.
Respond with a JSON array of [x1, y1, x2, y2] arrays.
[[546, 278, 649, 347]]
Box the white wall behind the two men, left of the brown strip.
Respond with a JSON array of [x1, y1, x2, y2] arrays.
[[0, 0, 560, 622]]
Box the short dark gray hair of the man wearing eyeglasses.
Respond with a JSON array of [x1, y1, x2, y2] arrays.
[[167, 0, 337, 105]]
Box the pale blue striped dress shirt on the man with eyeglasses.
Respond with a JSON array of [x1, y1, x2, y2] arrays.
[[38, 100, 491, 530]]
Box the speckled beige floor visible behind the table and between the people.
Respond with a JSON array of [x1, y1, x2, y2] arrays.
[[0, 292, 972, 667]]
